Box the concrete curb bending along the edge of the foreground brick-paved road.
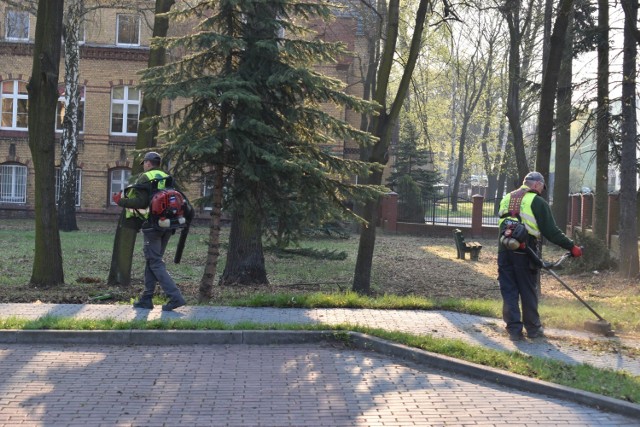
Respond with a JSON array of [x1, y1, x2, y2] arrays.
[[0, 330, 640, 419]]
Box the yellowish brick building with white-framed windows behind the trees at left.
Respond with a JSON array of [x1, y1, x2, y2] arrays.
[[0, 1, 366, 221]]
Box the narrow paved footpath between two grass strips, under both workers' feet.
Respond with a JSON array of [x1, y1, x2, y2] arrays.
[[0, 304, 640, 375]]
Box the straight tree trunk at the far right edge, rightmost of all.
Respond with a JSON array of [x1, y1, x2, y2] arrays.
[[618, 0, 638, 278]]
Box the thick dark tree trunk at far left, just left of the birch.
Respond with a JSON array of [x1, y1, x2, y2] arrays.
[[27, 0, 64, 286]]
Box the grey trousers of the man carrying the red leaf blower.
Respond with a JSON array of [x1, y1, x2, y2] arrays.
[[141, 229, 184, 301]]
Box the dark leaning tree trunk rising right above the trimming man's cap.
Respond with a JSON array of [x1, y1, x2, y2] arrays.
[[536, 0, 573, 180]]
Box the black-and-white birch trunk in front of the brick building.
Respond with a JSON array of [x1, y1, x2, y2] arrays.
[[58, 0, 83, 231]]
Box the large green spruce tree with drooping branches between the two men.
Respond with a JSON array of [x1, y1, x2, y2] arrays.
[[142, 0, 380, 290]]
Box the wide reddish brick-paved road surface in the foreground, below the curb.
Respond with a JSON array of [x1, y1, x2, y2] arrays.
[[0, 344, 638, 427]]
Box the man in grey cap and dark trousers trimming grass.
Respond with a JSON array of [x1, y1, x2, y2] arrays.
[[498, 172, 582, 341]]
